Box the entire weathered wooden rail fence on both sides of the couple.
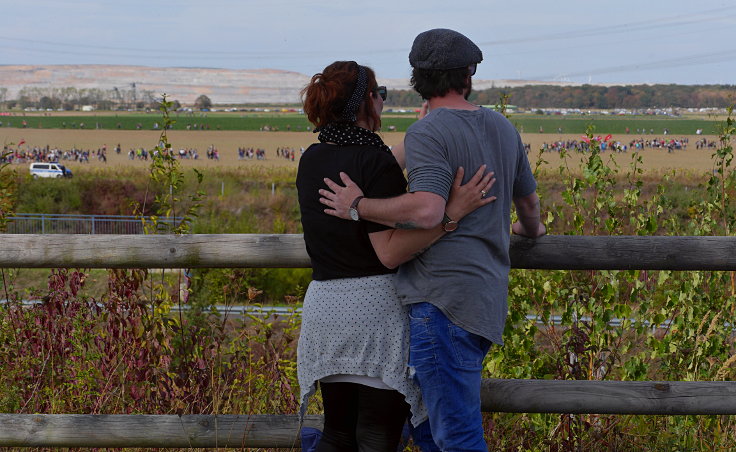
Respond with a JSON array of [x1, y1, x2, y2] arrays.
[[0, 234, 736, 448]]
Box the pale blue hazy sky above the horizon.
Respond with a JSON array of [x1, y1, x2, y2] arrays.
[[0, 0, 736, 86]]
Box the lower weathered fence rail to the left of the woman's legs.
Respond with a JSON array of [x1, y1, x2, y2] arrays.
[[0, 414, 322, 449]]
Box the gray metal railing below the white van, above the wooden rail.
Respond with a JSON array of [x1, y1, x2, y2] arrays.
[[6, 213, 182, 235]]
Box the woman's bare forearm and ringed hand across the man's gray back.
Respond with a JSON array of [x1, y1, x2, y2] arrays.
[[368, 165, 496, 268]]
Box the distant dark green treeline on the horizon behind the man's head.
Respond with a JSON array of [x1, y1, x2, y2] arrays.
[[388, 85, 736, 109]]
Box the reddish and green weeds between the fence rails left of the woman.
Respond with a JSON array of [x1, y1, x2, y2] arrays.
[[0, 270, 296, 414]]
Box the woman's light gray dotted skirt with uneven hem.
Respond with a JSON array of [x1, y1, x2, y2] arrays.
[[297, 274, 427, 425]]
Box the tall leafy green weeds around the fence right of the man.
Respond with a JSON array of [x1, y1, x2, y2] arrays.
[[486, 116, 736, 450]]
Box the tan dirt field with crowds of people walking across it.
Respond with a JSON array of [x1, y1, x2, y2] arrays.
[[0, 129, 717, 176]]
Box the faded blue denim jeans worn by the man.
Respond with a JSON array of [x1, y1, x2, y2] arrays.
[[409, 303, 491, 452]]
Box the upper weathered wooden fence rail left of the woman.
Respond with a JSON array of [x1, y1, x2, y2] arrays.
[[0, 234, 311, 268]]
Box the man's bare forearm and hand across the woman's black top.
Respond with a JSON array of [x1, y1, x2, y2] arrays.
[[319, 173, 445, 229]]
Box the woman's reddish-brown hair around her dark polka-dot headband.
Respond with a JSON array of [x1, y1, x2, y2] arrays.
[[301, 61, 381, 130]]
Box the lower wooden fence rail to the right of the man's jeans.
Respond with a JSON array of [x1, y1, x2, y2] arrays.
[[481, 379, 736, 415]]
